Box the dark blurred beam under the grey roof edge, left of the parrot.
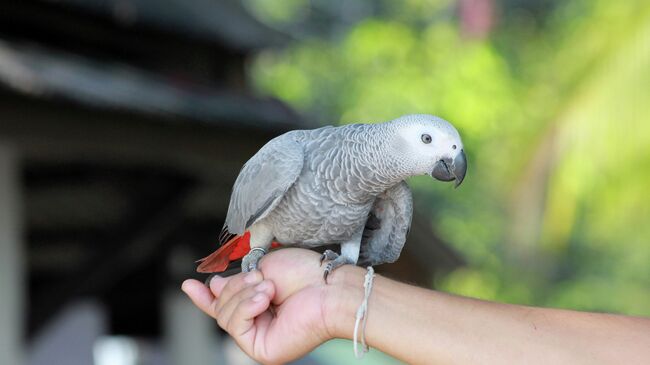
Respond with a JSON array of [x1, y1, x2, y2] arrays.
[[0, 93, 276, 181]]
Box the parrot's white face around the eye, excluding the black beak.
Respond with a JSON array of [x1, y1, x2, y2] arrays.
[[397, 115, 463, 174]]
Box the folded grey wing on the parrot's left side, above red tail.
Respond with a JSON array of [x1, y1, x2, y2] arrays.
[[220, 132, 305, 236]]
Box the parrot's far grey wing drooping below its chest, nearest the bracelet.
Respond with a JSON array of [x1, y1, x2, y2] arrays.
[[359, 181, 413, 265]]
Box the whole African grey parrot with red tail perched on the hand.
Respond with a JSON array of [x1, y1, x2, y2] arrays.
[[197, 114, 467, 280]]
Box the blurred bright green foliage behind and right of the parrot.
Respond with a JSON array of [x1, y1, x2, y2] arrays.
[[252, 0, 650, 315]]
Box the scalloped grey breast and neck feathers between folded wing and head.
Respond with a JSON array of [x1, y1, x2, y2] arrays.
[[263, 126, 386, 246]]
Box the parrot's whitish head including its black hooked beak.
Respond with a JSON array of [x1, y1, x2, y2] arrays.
[[391, 114, 467, 187]]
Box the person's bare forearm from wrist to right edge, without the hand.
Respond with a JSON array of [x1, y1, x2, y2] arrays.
[[328, 267, 650, 364]]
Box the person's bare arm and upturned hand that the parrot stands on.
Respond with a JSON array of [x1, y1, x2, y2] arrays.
[[183, 248, 650, 365]]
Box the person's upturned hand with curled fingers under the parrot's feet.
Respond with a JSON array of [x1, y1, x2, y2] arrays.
[[182, 248, 362, 364]]
